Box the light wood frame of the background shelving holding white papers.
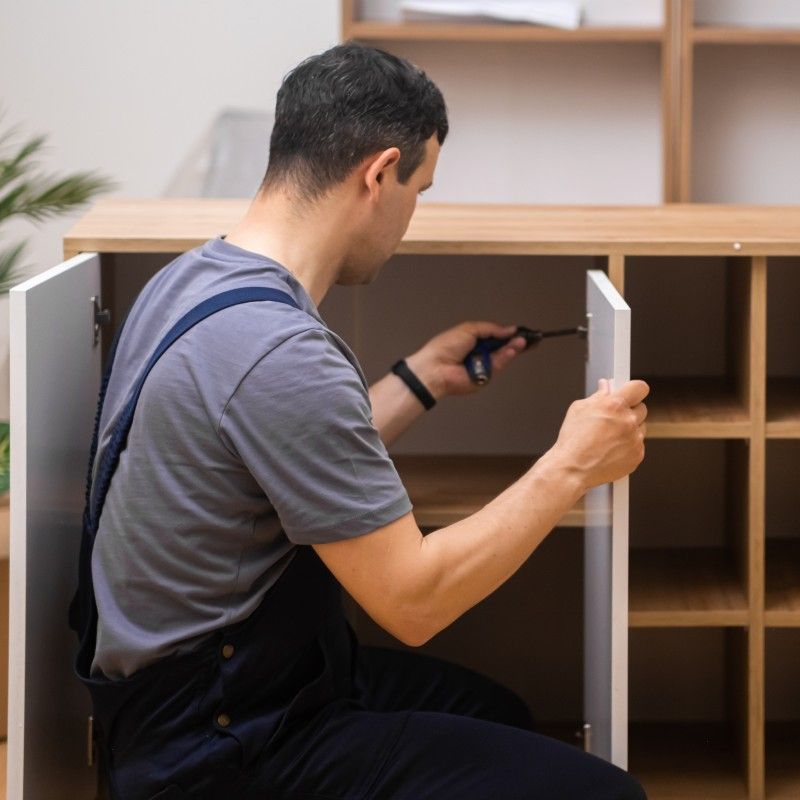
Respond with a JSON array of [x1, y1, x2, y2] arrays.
[[341, 0, 800, 203]]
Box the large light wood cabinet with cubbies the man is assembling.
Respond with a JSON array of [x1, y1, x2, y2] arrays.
[[10, 199, 800, 800]]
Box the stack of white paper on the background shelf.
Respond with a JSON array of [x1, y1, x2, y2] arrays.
[[400, 0, 581, 29]]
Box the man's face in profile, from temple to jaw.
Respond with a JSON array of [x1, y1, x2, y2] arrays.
[[337, 134, 439, 284]]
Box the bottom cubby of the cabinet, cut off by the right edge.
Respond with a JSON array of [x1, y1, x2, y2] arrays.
[[765, 630, 800, 800]]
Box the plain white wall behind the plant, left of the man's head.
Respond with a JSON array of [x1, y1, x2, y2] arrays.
[[0, 0, 339, 412]]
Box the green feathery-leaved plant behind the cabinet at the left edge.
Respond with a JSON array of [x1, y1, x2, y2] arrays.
[[0, 115, 115, 504]]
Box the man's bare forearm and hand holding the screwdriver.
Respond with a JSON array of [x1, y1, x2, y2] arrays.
[[369, 322, 525, 446]]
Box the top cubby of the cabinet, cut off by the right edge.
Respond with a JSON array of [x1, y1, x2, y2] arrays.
[[767, 258, 800, 439]]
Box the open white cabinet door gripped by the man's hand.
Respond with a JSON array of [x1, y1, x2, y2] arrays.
[[584, 270, 631, 769]]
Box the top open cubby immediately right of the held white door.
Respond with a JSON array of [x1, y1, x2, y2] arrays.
[[625, 257, 758, 438]]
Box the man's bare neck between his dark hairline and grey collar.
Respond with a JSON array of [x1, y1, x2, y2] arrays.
[[225, 184, 348, 306]]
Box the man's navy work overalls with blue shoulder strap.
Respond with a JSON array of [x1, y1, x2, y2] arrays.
[[70, 287, 644, 800]]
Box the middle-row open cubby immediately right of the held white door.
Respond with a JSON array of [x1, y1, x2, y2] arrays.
[[629, 439, 748, 627]]
